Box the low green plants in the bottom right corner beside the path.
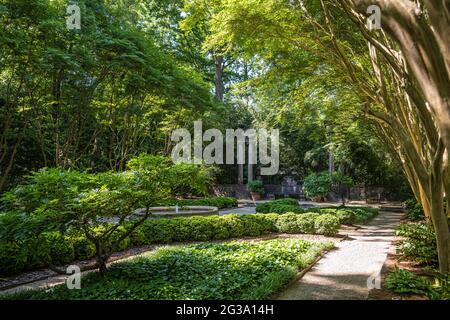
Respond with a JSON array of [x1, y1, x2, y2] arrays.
[[385, 269, 450, 300]]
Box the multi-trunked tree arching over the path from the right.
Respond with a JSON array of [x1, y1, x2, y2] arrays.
[[208, 0, 450, 272]]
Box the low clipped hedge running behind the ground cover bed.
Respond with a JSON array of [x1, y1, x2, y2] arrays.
[[0, 213, 340, 275]]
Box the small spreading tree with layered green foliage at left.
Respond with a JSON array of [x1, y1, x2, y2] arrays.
[[0, 155, 211, 272]]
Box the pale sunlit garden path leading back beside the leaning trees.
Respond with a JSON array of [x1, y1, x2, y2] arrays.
[[277, 211, 403, 300]]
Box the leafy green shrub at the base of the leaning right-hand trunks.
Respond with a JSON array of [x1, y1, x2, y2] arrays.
[[396, 223, 438, 266]]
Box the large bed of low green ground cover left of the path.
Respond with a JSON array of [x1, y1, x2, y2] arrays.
[[4, 240, 333, 300]]
